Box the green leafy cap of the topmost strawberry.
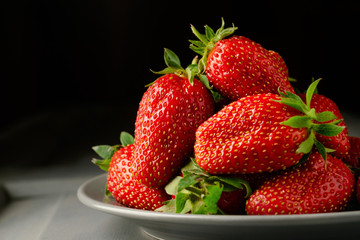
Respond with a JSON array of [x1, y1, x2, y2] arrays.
[[189, 18, 237, 73]]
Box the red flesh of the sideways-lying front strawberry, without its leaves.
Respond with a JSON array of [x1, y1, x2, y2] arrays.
[[195, 93, 307, 174]]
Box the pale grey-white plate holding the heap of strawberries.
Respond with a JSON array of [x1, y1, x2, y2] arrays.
[[77, 174, 360, 240]]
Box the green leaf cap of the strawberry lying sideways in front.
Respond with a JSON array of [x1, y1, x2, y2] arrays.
[[276, 79, 345, 164]]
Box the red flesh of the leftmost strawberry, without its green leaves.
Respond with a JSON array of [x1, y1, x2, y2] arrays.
[[107, 144, 169, 210]]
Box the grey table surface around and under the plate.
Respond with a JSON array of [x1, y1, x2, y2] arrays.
[[0, 111, 360, 240]]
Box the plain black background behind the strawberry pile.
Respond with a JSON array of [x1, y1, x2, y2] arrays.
[[0, 0, 360, 166]]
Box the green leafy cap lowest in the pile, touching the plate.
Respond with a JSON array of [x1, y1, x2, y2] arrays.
[[156, 158, 252, 214]]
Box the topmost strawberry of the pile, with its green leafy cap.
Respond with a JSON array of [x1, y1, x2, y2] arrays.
[[190, 18, 294, 101]]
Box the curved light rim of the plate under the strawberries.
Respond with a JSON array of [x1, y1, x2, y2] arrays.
[[77, 173, 360, 226]]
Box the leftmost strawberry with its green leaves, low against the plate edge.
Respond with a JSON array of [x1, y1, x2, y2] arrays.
[[92, 132, 169, 210]]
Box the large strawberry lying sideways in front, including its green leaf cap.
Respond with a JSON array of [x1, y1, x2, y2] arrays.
[[194, 80, 343, 174]]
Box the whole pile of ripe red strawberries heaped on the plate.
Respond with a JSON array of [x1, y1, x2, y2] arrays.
[[93, 21, 360, 214]]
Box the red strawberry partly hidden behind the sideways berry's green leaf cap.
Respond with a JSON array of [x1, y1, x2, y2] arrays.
[[299, 94, 350, 158]]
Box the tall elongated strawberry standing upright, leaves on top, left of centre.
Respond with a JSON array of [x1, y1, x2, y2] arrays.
[[133, 49, 214, 187]]
